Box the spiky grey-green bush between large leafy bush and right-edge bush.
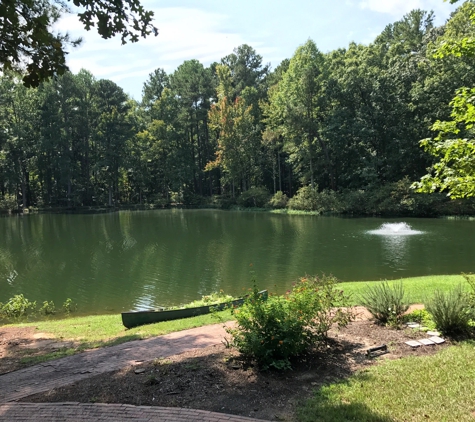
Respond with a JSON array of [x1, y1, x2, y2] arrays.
[[361, 281, 409, 326]]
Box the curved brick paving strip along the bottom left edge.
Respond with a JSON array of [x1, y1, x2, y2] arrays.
[[0, 402, 268, 422]]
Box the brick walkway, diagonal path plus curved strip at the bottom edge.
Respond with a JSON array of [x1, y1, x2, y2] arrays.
[[0, 324, 272, 422]]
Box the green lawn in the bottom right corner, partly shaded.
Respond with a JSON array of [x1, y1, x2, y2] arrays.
[[298, 341, 475, 422]]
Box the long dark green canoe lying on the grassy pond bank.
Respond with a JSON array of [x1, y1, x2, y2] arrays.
[[122, 290, 267, 328]]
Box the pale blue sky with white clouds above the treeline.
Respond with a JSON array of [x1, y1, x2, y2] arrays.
[[57, 0, 456, 100]]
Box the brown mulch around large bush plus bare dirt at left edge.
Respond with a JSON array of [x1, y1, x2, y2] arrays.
[[0, 306, 449, 421]]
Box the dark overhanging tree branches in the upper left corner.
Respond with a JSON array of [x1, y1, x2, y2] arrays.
[[0, 0, 158, 87]]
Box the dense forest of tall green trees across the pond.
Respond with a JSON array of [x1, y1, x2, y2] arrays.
[[0, 2, 475, 216]]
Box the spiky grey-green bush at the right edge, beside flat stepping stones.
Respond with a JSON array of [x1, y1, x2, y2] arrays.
[[426, 285, 473, 335]]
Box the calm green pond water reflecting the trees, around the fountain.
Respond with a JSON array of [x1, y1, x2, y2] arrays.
[[0, 210, 475, 313]]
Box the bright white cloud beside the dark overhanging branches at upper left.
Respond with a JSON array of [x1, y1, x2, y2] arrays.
[[56, 7, 249, 94]]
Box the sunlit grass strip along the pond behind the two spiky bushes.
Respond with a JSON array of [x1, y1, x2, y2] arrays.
[[339, 275, 468, 305]]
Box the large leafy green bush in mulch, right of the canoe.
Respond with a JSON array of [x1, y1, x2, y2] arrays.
[[227, 276, 353, 369]]
